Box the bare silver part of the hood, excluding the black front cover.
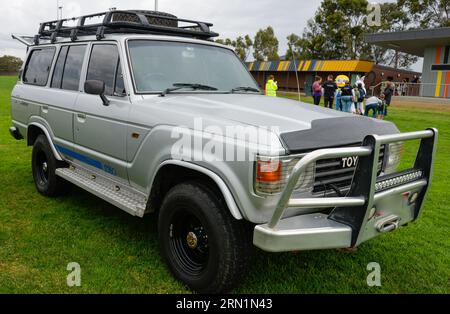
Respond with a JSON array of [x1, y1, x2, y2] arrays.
[[143, 94, 354, 133]]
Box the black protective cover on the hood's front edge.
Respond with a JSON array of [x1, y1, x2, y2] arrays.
[[280, 116, 399, 154]]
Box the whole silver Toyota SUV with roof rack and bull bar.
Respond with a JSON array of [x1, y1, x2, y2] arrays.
[[10, 11, 437, 293]]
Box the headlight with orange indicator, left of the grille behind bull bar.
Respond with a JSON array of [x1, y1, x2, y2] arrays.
[[255, 156, 314, 195]]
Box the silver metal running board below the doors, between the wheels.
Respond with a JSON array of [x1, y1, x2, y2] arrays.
[[56, 166, 147, 217]]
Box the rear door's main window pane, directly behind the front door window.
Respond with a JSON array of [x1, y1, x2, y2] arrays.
[[58, 45, 86, 91]]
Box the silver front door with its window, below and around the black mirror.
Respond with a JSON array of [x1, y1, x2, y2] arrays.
[[74, 42, 130, 181]]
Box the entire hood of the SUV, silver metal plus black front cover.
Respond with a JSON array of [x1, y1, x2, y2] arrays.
[[139, 94, 398, 153]]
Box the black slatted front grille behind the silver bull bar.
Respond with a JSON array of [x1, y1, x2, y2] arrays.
[[313, 146, 385, 195]]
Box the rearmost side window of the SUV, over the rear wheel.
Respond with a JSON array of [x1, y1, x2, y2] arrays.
[[23, 48, 55, 86]]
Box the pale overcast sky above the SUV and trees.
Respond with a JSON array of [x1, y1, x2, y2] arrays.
[[0, 0, 421, 71]]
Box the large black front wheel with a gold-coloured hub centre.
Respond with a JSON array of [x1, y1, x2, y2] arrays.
[[158, 182, 252, 293]]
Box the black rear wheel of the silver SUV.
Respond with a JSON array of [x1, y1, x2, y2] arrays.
[[31, 135, 69, 197]]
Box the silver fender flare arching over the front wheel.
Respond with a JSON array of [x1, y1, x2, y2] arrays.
[[156, 160, 243, 220]]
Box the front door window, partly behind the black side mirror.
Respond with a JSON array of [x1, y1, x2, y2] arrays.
[[86, 45, 125, 96]]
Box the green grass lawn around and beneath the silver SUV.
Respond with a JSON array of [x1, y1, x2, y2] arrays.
[[0, 77, 450, 293]]
